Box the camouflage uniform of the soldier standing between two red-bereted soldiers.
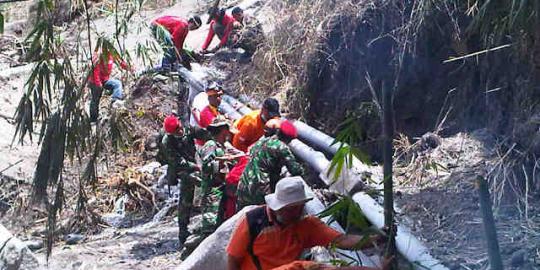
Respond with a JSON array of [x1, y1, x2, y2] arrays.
[[198, 140, 225, 236]]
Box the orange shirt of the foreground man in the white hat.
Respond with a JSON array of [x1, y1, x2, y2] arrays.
[[227, 208, 342, 270]]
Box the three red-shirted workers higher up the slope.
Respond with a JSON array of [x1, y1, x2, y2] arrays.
[[88, 7, 265, 122]]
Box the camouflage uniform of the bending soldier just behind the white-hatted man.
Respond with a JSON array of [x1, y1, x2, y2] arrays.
[[237, 135, 303, 210]]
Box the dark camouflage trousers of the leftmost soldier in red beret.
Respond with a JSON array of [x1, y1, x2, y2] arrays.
[[178, 173, 200, 244]]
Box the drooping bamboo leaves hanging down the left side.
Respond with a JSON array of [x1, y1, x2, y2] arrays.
[[13, 0, 150, 257]]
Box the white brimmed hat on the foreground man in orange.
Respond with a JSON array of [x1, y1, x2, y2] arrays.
[[264, 176, 313, 211]]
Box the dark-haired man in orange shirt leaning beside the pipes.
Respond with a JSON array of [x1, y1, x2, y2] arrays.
[[233, 98, 281, 152]]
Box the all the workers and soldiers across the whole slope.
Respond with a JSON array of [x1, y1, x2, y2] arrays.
[[89, 4, 387, 270]]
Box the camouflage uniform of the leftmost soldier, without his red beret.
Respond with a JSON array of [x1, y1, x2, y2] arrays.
[[162, 128, 206, 243]]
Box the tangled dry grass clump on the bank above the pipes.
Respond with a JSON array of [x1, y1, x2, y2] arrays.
[[232, 0, 371, 116]]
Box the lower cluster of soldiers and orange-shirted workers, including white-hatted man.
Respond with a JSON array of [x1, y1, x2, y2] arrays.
[[162, 83, 388, 270]]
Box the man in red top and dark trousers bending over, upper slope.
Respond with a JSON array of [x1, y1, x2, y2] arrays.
[[150, 16, 202, 71]]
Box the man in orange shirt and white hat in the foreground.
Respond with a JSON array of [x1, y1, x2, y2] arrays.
[[227, 176, 388, 270]]
